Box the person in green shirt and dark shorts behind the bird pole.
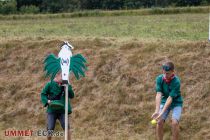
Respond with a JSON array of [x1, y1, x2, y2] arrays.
[[41, 72, 74, 140]]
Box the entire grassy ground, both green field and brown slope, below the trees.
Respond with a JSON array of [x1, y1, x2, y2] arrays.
[[0, 9, 210, 140]]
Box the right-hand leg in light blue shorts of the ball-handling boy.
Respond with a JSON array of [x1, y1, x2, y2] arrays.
[[171, 106, 182, 140]]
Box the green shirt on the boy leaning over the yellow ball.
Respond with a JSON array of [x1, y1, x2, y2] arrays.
[[156, 74, 183, 107]]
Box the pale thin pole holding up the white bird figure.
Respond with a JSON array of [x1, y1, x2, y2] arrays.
[[64, 84, 68, 140]]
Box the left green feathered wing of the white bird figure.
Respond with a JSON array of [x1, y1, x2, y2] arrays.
[[44, 54, 61, 81]]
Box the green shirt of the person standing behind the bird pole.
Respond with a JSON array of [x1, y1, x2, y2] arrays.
[[41, 81, 74, 114]]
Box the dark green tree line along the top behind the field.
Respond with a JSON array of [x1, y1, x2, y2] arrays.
[[0, 0, 210, 14]]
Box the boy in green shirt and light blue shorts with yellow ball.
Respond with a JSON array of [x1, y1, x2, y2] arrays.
[[152, 62, 183, 140]]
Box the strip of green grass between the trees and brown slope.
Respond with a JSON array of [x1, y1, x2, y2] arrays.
[[0, 13, 209, 41]]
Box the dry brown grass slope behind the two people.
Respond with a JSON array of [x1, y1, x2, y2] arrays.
[[0, 38, 210, 140]]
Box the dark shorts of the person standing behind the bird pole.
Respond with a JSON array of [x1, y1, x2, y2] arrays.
[[47, 113, 70, 130]]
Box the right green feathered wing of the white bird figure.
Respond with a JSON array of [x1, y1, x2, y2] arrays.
[[69, 54, 87, 79]]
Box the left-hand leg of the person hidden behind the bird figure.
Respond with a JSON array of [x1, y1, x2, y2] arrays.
[[47, 113, 56, 140]]
